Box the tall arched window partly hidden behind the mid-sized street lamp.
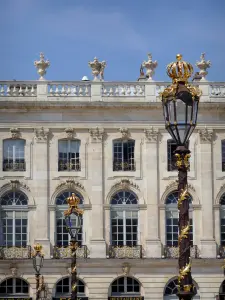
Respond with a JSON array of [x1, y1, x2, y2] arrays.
[[56, 191, 83, 247]]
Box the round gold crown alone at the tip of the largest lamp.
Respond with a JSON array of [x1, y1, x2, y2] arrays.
[[167, 54, 193, 83]]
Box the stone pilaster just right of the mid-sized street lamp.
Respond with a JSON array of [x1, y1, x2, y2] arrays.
[[89, 127, 106, 258]]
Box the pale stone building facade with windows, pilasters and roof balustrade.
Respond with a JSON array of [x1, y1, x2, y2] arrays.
[[0, 58, 225, 300]]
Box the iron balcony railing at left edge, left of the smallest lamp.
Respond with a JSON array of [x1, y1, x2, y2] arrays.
[[0, 246, 31, 260]]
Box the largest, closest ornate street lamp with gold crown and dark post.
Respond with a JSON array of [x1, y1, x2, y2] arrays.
[[161, 54, 202, 300]]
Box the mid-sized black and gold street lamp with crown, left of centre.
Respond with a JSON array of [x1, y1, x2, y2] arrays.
[[64, 193, 84, 300]]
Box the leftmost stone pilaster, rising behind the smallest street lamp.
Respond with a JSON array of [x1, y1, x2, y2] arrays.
[[33, 127, 50, 258]]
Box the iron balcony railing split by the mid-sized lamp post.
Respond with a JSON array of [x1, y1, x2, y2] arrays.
[[53, 245, 88, 259]]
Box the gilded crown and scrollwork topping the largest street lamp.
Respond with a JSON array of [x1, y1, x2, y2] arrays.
[[160, 54, 202, 101]]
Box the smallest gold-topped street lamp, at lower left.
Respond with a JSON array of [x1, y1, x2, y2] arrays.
[[33, 243, 44, 300]]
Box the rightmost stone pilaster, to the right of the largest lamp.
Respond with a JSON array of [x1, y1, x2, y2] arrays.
[[199, 128, 216, 258]]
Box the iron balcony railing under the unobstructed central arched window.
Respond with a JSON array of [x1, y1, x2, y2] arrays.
[[107, 245, 142, 258]]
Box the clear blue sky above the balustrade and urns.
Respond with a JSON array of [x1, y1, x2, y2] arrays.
[[0, 0, 225, 81]]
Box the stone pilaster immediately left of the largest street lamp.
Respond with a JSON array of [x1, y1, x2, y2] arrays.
[[144, 127, 161, 257]]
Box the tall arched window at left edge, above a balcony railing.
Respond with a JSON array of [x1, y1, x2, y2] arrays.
[[0, 191, 28, 247]]
